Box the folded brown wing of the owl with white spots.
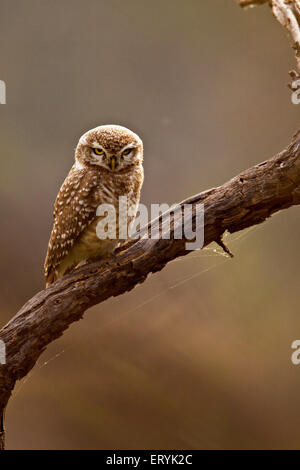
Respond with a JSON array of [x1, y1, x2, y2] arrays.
[[44, 167, 100, 284]]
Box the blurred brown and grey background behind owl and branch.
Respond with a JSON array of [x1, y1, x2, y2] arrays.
[[0, 0, 300, 449]]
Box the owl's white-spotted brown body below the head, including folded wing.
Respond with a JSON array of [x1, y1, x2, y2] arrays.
[[44, 165, 143, 285]]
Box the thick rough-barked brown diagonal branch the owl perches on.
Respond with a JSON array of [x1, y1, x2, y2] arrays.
[[0, 132, 300, 448]]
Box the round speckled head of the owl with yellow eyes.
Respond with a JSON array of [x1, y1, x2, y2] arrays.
[[75, 124, 143, 172]]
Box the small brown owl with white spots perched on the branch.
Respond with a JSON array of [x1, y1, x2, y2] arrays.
[[44, 125, 144, 287]]
